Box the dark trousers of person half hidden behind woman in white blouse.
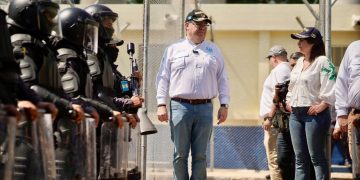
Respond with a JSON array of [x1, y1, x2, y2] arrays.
[[277, 132, 295, 180]]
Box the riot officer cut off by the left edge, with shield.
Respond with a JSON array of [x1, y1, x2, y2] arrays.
[[0, 9, 25, 179]]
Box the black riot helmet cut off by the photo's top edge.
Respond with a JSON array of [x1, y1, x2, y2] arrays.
[[8, 0, 59, 34]]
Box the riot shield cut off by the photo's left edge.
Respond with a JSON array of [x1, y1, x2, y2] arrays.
[[0, 110, 16, 180]]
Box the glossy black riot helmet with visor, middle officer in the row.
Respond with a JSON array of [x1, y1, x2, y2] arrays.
[[58, 7, 99, 52]]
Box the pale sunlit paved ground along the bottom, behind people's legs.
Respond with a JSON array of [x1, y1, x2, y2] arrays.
[[147, 169, 351, 180]]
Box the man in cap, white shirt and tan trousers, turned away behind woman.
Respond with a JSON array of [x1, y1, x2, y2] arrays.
[[260, 45, 291, 180]]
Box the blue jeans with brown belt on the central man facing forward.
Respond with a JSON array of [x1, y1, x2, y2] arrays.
[[170, 101, 213, 180]]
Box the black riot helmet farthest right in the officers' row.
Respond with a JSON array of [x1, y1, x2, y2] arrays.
[[84, 4, 118, 42]]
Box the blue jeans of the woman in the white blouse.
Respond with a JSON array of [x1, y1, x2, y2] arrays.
[[289, 107, 330, 180]]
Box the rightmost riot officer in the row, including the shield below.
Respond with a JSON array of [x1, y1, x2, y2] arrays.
[[84, 4, 147, 179]]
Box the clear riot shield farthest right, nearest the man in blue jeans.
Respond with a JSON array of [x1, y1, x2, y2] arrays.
[[99, 117, 129, 180]]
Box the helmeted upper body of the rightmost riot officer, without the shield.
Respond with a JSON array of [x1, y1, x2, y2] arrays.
[[85, 4, 143, 116]]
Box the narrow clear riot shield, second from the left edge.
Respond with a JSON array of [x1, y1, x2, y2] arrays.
[[37, 111, 56, 180]]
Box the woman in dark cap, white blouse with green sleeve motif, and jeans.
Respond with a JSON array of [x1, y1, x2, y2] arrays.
[[288, 27, 336, 180]]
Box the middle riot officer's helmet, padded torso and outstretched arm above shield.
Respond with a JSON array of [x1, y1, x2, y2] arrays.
[[55, 8, 123, 177]]
